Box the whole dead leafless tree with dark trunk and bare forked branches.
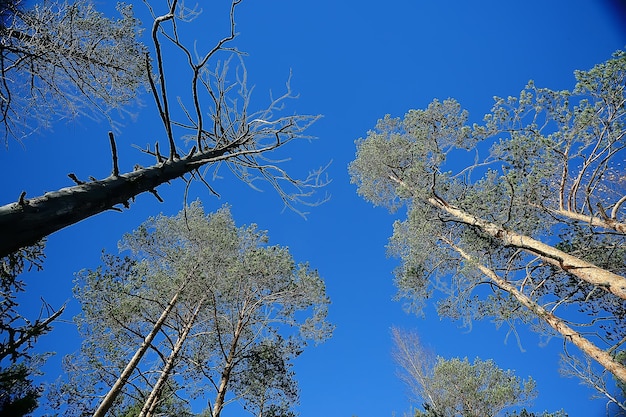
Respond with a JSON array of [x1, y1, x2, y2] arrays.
[[0, 0, 328, 256]]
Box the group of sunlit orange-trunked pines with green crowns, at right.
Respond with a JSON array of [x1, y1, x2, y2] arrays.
[[350, 52, 626, 406]]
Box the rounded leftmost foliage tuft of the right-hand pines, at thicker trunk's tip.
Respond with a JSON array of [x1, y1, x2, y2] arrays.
[[348, 99, 473, 210]]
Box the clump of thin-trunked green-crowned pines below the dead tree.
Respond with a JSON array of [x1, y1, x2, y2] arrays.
[[53, 204, 332, 417]]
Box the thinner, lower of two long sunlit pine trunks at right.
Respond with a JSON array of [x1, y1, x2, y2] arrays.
[[442, 238, 626, 382]]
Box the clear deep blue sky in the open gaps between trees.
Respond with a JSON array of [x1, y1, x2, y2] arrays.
[[0, 0, 626, 417]]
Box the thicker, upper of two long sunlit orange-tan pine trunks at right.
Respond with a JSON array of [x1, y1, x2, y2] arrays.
[[390, 176, 626, 300]]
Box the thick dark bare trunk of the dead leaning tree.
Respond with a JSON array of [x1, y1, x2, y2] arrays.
[[0, 142, 241, 258]]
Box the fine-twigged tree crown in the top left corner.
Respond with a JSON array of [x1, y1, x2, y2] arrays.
[[0, 0, 147, 141]]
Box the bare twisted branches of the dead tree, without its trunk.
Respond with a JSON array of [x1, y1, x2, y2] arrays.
[[144, 0, 328, 214]]
